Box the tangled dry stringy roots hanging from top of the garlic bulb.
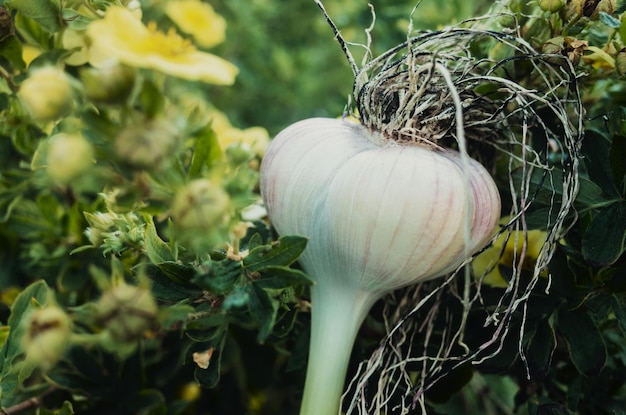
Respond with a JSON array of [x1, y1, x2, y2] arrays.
[[315, 0, 583, 415]]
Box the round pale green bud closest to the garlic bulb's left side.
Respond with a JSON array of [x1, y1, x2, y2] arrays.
[[172, 179, 230, 230]]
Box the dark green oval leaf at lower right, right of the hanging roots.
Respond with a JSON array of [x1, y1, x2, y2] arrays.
[[557, 308, 607, 376]]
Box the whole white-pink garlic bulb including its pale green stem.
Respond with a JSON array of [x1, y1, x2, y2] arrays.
[[261, 118, 500, 415]]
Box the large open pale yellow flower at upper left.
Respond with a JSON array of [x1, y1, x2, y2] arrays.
[[87, 6, 238, 85]]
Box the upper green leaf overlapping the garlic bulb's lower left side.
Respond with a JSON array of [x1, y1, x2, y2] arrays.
[[243, 236, 308, 271]]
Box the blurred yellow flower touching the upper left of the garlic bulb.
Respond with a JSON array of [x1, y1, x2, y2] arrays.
[[211, 110, 270, 157]]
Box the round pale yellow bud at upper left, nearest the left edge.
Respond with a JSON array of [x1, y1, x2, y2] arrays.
[[18, 66, 73, 121]]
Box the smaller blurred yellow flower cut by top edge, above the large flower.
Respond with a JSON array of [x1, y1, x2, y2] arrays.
[[165, 0, 226, 48]]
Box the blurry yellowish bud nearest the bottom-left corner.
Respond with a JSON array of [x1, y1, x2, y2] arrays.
[[22, 305, 72, 370]]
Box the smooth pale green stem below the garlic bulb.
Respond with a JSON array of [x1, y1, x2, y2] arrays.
[[300, 284, 378, 415]]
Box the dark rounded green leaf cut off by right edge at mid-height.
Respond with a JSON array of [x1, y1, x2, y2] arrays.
[[582, 201, 626, 265]]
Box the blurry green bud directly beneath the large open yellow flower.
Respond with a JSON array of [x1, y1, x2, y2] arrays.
[[80, 63, 135, 104]]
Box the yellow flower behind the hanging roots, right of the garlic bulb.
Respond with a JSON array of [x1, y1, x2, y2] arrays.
[[472, 218, 547, 287]]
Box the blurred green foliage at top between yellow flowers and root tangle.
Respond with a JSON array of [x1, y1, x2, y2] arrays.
[[210, 0, 490, 135]]
